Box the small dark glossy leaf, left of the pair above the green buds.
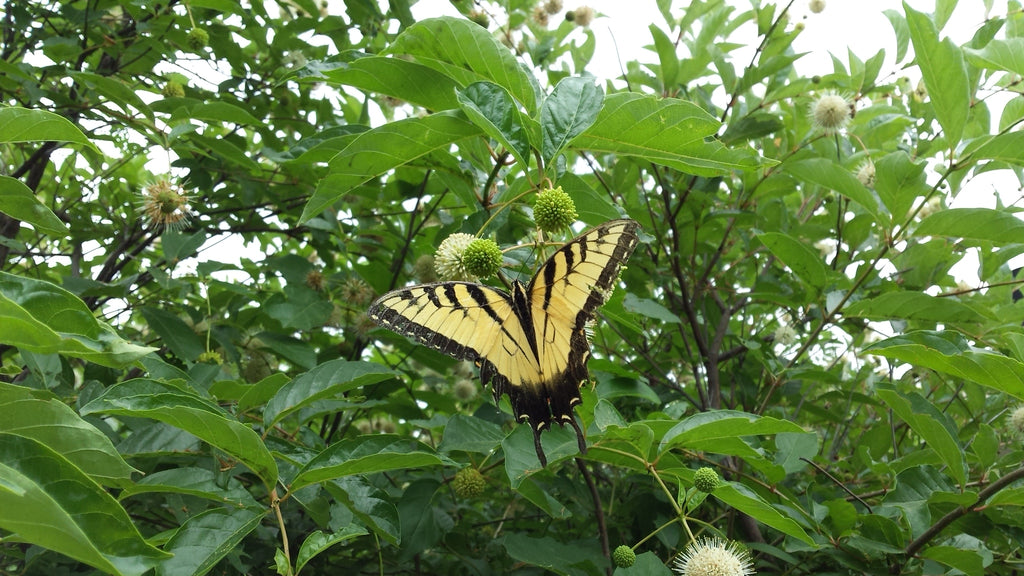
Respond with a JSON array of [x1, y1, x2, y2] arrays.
[[458, 82, 530, 170]]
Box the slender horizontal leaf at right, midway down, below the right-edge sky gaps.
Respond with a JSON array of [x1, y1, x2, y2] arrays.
[[843, 292, 985, 324]]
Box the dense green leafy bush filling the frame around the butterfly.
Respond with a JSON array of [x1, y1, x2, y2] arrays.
[[0, 0, 1024, 576]]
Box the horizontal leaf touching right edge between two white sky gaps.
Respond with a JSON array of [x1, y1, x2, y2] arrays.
[[918, 208, 1024, 244]]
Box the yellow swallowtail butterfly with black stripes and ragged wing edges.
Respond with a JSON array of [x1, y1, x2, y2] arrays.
[[369, 219, 639, 466]]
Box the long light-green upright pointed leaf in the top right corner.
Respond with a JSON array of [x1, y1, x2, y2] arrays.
[[903, 2, 971, 149]]
